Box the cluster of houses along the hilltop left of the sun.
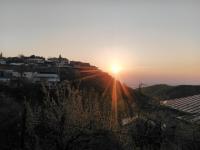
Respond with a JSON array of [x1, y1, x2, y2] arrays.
[[0, 53, 97, 86]]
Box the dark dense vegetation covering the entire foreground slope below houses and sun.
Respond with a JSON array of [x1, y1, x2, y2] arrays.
[[0, 78, 200, 150]]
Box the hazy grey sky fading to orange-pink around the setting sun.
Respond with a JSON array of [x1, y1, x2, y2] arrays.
[[0, 0, 200, 87]]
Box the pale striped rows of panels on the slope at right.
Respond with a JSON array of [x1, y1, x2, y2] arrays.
[[162, 94, 200, 122]]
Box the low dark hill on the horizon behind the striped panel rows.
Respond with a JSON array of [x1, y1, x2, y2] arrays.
[[142, 84, 200, 100]]
